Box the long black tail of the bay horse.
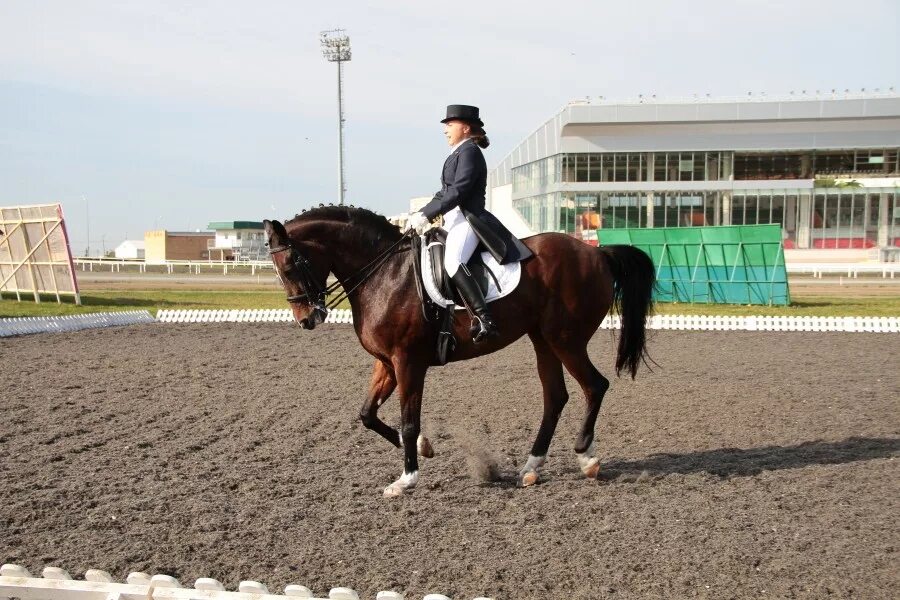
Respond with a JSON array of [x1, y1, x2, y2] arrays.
[[600, 245, 656, 379]]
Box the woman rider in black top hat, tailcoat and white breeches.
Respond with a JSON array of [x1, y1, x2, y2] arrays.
[[409, 104, 531, 344]]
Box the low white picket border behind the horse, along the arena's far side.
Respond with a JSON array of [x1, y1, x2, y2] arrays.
[[156, 308, 900, 333]]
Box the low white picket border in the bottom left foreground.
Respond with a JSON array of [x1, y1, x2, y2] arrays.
[[0, 564, 492, 600]]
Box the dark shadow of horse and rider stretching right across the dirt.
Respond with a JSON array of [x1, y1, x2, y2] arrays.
[[487, 437, 900, 486]]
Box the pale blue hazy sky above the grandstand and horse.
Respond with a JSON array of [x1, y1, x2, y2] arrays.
[[0, 0, 900, 255]]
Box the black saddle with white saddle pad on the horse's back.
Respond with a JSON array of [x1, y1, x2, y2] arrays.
[[412, 228, 521, 365]]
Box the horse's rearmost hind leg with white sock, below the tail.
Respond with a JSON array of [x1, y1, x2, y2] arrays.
[[554, 345, 609, 479]]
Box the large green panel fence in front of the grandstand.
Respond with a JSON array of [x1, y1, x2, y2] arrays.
[[597, 224, 791, 305]]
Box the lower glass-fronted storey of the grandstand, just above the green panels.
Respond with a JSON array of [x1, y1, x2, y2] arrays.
[[513, 188, 900, 248]]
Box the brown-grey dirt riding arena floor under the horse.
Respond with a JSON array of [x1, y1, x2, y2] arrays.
[[0, 324, 900, 600]]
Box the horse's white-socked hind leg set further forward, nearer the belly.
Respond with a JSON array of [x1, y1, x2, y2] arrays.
[[519, 335, 569, 486]]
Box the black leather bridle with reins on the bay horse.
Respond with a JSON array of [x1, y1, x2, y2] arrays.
[[269, 229, 413, 321]]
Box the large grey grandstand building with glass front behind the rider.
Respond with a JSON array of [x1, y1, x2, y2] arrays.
[[488, 92, 900, 249]]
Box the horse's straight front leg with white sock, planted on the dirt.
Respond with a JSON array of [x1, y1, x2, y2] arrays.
[[384, 357, 428, 498]]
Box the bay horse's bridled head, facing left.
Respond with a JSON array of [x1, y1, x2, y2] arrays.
[[263, 220, 329, 329]]
